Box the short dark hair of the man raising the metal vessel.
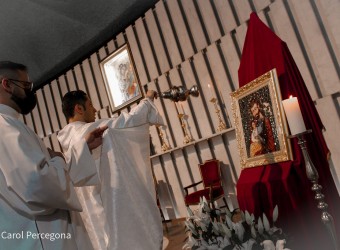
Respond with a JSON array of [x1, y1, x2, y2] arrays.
[[62, 90, 88, 121]]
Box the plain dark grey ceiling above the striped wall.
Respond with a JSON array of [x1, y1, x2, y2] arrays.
[[0, 0, 158, 88]]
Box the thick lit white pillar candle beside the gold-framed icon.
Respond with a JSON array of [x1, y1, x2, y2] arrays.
[[282, 96, 306, 135]]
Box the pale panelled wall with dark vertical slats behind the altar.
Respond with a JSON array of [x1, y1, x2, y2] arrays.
[[23, 0, 340, 218]]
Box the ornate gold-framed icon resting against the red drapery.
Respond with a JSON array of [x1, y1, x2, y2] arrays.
[[230, 69, 292, 168]]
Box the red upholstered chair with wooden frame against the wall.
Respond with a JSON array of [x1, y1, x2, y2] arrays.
[[184, 159, 227, 206]]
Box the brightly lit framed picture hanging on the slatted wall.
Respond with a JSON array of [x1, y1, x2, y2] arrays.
[[100, 44, 143, 112]]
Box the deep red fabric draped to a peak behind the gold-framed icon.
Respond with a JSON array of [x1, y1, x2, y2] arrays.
[[237, 13, 340, 250]]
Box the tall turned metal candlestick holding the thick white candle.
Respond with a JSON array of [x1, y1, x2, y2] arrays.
[[288, 129, 339, 249]]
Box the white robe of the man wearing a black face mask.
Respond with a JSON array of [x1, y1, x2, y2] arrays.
[[0, 104, 99, 250]]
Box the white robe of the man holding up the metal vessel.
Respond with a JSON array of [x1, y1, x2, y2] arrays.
[[58, 98, 163, 250]]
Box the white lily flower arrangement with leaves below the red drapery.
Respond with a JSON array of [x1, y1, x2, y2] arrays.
[[182, 197, 289, 250]]
